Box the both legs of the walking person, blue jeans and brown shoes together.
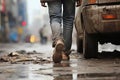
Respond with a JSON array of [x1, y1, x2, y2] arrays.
[[48, 0, 75, 63]]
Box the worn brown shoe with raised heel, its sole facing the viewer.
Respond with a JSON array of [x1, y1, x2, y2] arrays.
[[52, 40, 64, 63]]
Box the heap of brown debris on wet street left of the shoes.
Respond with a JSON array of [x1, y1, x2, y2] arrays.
[[0, 50, 52, 64]]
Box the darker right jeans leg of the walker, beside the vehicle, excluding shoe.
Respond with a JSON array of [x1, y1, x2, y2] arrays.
[[62, 0, 75, 52]]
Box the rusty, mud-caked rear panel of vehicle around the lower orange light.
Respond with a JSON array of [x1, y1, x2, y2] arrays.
[[83, 5, 120, 33]]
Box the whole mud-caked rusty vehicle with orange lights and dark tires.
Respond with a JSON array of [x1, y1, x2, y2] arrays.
[[75, 0, 120, 58]]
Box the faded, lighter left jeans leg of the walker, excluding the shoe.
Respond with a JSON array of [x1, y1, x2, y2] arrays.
[[48, 1, 63, 47]]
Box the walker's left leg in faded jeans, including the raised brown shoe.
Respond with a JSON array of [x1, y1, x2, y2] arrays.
[[48, 1, 64, 63]]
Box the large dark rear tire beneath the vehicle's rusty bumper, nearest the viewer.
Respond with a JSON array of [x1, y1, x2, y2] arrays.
[[83, 31, 98, 59]]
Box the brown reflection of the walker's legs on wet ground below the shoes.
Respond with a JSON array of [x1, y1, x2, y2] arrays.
[[53, 62, 77, 80]]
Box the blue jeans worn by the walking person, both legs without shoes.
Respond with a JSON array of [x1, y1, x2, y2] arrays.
[[48, 0, 75, 51]]
